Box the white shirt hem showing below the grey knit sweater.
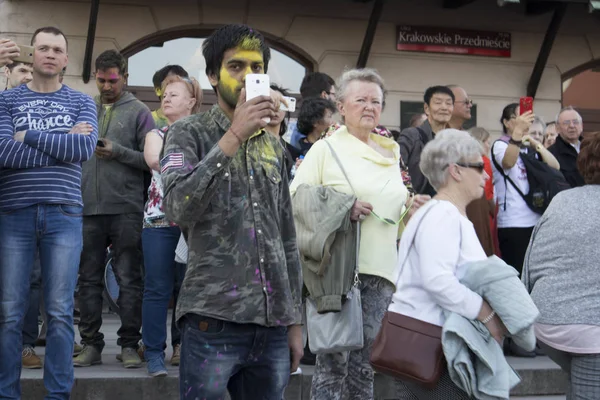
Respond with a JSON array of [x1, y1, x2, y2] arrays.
[[534, 323, 600, 354]]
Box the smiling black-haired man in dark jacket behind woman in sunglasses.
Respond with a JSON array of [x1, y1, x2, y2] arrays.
[[398, 86, 455, 196]]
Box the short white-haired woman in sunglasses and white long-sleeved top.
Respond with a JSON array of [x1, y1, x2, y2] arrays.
[[389, 129, 505, 400]]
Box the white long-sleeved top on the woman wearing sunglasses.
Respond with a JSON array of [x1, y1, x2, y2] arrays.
[[388, 200, 487, 326]]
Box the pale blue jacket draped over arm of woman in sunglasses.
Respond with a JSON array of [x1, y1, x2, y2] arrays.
[[442, 256, 539, 400]]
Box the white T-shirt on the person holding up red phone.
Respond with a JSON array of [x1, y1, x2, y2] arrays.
[[492, 140, 541, 228]]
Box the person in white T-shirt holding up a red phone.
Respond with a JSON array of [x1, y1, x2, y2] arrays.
[[491, 103, 559, 357]]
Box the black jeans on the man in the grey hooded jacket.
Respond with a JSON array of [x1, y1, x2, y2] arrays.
[[78, 213, 143, 352]]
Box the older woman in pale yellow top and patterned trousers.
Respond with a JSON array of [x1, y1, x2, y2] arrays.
[[291, 69, 416, 400]]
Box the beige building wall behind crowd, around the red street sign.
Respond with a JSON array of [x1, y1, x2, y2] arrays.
[[0, 0, 600, 133]]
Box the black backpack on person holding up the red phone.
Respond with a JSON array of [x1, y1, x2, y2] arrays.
[[492, 141, 571, 214]]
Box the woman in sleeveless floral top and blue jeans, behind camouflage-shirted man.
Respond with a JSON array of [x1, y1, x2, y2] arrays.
[[142, 76, 202, 376]]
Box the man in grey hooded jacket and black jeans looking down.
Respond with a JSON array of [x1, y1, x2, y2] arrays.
[[73, 50, 155, 368]]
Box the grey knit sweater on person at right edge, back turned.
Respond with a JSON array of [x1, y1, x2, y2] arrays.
[[523, 185, 600, 326]]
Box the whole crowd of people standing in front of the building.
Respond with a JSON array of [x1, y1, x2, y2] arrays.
[[0, 21, 600, 400]]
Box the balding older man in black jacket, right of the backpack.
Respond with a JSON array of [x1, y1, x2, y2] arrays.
[[548, 107, 585, 187]]
